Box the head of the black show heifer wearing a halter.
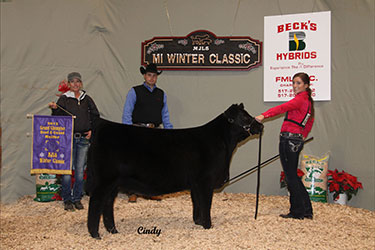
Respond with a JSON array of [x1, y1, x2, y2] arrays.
[[224, 103, 264, 141]]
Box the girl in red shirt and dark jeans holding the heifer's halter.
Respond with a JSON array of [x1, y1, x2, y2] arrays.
[[255, 73, 314, 219]]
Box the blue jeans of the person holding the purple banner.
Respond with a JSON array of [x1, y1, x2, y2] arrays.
[[61, 137, 90, 202]]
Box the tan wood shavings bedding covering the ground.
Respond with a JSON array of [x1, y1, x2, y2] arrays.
[[0, 192, 375, 250]]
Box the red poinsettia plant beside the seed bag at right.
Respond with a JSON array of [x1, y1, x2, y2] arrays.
[[327, 169, 363, 201]]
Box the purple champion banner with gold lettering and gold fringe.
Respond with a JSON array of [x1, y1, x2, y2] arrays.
[[30, 115, 73, 174]]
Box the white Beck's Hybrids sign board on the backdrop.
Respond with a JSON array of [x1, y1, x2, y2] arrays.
[[264, 11, 331, 102]]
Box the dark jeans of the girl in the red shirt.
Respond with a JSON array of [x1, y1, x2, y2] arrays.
[[279, 136, 313, 216]]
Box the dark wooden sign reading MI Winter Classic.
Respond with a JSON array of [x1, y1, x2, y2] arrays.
[[141, 30, 262, 70]]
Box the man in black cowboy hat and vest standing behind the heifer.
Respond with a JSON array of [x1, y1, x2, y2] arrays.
[[122, 63, 173, 202]]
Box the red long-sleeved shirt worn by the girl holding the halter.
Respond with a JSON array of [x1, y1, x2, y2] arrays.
[[262, 91, 314, 137]]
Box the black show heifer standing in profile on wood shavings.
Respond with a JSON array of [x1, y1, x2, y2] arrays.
[[87, 103, 263, 238]]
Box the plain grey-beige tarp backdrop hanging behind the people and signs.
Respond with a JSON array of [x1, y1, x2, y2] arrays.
[[0, 0, 375, 210]]
